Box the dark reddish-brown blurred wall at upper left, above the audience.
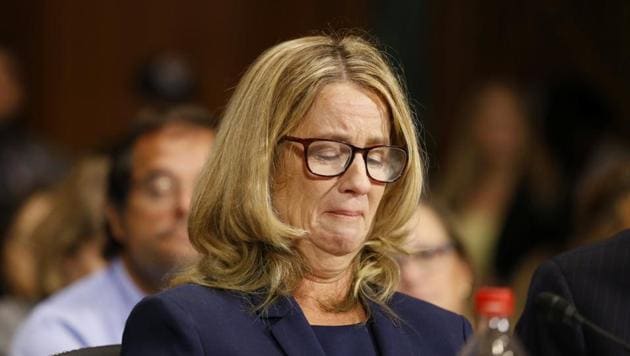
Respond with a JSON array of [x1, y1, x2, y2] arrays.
[[0, 0, 367, 151]]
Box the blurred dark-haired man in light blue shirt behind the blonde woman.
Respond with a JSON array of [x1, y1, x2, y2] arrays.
[[11, 107, 221, 356]]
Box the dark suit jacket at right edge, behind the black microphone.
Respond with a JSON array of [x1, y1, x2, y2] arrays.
[[516, 230, 630, 356]]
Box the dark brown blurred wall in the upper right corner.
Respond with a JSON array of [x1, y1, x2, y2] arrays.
[[427, 0, 630, 150]]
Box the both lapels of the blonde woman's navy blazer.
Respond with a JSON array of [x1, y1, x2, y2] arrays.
[[261, 297, 420, 356]]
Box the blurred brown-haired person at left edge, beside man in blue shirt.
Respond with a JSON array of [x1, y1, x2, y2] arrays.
[[0, 156, 108, 355]]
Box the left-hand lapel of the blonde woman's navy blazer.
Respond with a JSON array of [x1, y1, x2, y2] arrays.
[[263, 297, 325, 356]]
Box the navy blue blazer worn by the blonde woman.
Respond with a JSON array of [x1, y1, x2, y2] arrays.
[[121, 284, 471, 356]]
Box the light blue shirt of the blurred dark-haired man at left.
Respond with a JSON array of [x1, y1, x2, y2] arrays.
[[11, 259, 144, 356]]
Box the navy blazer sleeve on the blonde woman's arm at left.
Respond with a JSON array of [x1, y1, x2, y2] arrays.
[[121, 297, 204, 356]]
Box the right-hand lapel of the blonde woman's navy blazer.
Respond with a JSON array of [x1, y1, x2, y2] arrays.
[[370, 302, 421, 356]]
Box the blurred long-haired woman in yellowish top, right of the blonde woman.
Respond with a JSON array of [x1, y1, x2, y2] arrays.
[[436, 81, 569, 283]]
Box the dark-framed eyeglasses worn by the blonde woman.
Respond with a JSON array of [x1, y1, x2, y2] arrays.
[[281, 136, 407, 183]]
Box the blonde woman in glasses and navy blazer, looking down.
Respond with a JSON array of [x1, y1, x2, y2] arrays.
[[122, 36, 470, 356]]
